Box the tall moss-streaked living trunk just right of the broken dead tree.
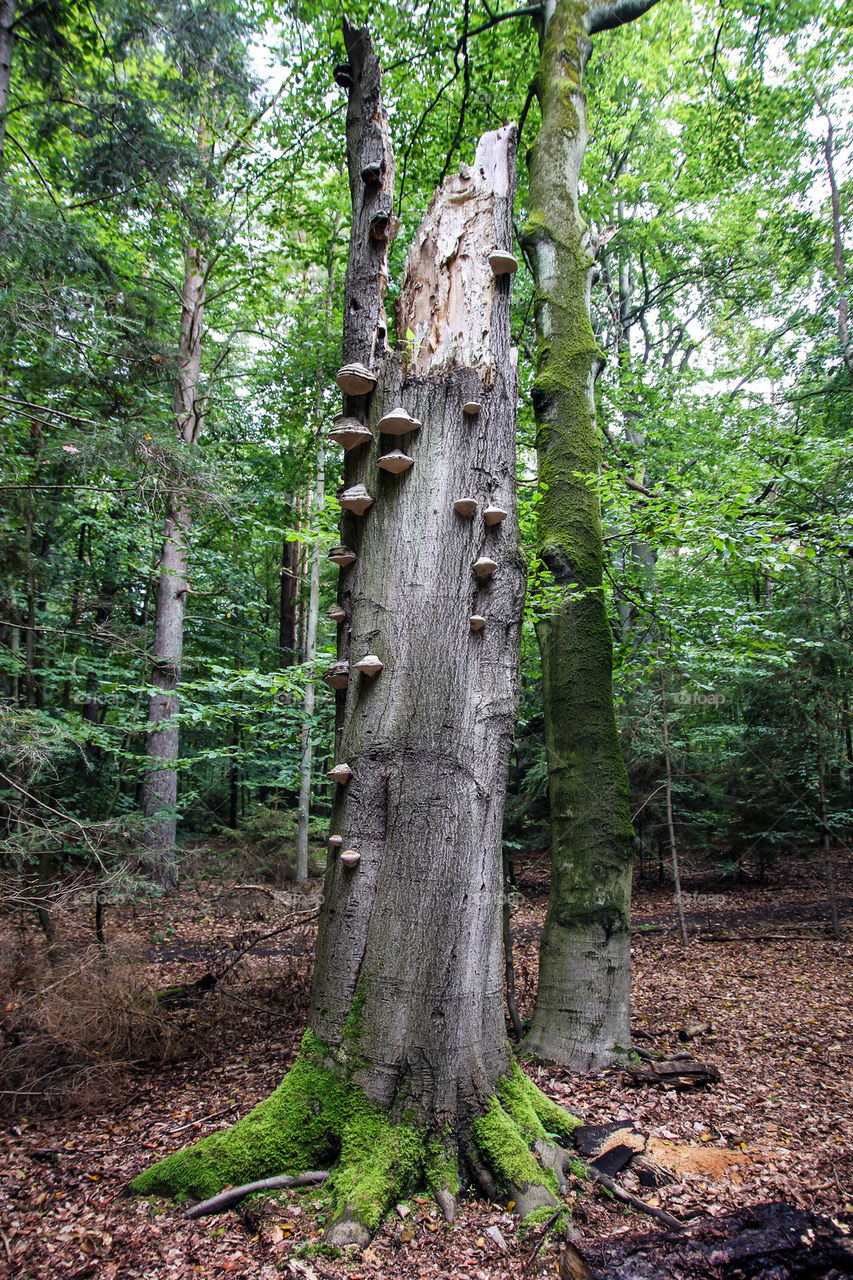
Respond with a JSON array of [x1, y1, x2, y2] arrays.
[[524, 0, 653, 1070]]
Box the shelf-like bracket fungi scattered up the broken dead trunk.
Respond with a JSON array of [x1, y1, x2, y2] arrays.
[[323, 244, 519, 870]]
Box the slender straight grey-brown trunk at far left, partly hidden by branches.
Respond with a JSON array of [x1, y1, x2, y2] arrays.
[[142, 246, 205, 887]]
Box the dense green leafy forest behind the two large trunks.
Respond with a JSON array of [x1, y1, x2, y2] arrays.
[[0, 0, 853, 952]]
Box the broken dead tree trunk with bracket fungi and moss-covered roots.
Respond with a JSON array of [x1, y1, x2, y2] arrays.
[[134, 24, 573, 1244]]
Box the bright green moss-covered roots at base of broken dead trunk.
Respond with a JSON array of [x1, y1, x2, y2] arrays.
[[131, 1032, 580, 1248]]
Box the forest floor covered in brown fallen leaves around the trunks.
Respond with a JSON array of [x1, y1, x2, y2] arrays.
[[0, 850, 853, 1280]]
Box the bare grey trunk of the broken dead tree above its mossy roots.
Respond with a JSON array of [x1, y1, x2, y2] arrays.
[[311, 17, 524, 1124]]
